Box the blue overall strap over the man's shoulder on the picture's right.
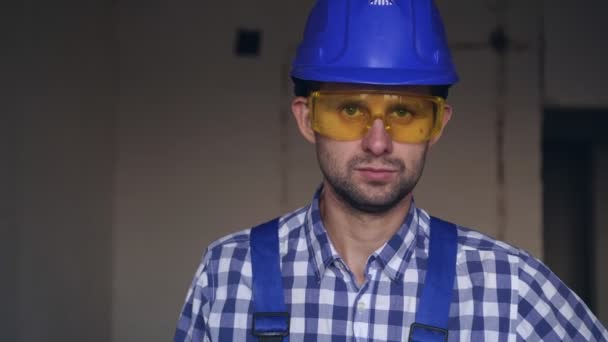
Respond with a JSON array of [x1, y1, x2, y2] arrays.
[[410, 217, 458, 342]]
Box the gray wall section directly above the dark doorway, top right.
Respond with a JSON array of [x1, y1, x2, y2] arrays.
[[543, 0, 608, 108]]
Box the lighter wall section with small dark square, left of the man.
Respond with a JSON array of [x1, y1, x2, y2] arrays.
[[112, 1, 313, 341]]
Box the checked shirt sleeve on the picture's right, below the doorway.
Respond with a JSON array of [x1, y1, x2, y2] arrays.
[[516, 255, 608, 341]]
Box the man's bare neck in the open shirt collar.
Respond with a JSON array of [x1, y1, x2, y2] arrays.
[[319, 185, 412, 285]]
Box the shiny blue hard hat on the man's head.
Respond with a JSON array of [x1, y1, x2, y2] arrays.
[[291, 0, 458, 85]]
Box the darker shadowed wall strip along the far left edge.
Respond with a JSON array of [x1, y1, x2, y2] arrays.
[[7, 1, 118, 342]]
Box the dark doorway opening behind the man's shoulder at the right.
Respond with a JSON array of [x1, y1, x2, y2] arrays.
[[542, 108, 608, 312]]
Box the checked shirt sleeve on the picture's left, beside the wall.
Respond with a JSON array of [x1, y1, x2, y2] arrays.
[[173, 251, 214, 342]]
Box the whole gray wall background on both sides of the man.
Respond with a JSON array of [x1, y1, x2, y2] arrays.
[[0, 0, 608, 342]]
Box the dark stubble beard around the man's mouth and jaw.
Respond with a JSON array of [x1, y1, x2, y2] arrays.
[[317, 146, 428, 215]]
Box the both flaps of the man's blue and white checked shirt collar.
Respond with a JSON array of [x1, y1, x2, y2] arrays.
[[304, 186, 424, 281]]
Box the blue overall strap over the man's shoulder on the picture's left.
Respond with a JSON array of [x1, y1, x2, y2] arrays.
[[250, 219, 289, 342]]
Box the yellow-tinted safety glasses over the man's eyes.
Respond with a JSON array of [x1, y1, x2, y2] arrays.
[[309, 91, 444, 144]]
